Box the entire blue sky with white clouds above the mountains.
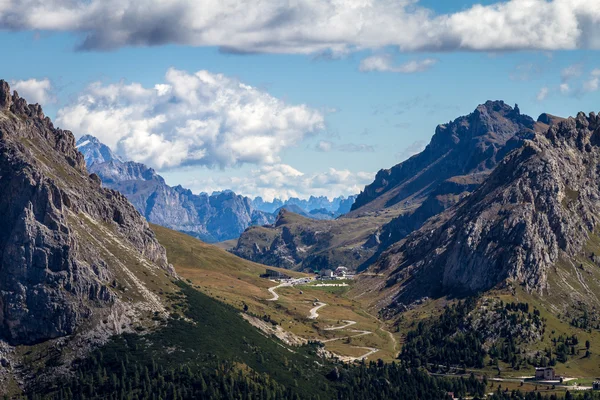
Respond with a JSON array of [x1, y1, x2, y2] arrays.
[[0, 0, 600, 200]]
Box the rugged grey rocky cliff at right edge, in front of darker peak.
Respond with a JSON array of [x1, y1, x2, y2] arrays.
[[374, 113, 600, 303]]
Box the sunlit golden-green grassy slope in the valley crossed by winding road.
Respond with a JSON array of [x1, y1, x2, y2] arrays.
[[152, 225, 397, 360]]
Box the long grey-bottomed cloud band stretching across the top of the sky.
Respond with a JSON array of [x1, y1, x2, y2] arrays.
[[0, 0, 600, 54]]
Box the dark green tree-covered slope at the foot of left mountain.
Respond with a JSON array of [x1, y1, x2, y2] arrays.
[[30, 282, 333, 399]]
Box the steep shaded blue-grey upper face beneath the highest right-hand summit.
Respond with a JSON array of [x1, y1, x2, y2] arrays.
[[352, 101, 535, 211]]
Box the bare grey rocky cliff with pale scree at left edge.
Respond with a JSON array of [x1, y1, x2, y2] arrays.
[[0, 81, 174, 345]]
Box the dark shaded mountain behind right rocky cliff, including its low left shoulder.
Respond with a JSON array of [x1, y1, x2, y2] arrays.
[[234, 101, 544, 269]]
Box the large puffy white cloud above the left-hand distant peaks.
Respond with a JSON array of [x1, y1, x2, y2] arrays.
[[57, 69, 324, 169]]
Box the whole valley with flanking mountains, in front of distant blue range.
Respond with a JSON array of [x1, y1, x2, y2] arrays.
[[0, 72, 600, 400]]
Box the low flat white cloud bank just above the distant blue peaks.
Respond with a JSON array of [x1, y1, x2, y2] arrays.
[[187, 164, 375, 201]]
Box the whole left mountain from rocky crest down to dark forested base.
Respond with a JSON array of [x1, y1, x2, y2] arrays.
[[0, 81, 352, 399]]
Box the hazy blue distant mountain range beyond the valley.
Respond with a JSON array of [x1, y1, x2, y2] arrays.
[[77, 135, 355, 243]]
